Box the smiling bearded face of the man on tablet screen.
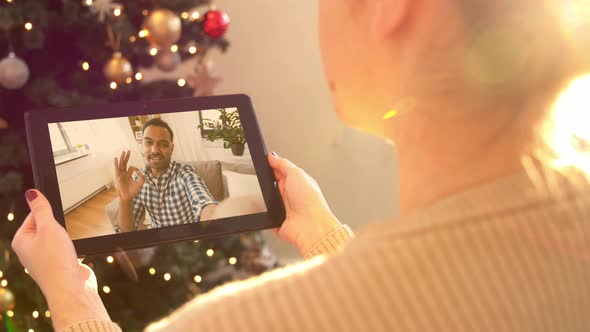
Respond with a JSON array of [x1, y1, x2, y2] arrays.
[[143, 126, 174, 170]]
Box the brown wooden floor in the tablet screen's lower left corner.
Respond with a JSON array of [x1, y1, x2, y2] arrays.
[[65, 187, 117, 240]]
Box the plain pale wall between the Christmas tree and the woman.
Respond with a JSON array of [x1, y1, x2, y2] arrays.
[[213, 0, 397, 261]]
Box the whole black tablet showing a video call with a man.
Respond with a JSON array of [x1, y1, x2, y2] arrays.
[[25, 95, 285, 257]]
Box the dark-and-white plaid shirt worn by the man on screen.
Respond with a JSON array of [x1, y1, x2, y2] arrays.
[[125, 161, 218, 230]]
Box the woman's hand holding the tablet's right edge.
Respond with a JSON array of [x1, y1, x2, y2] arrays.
[[268, 152, 342, 255]]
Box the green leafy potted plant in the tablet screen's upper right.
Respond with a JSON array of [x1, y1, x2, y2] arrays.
[[199, 109, 246, 156]]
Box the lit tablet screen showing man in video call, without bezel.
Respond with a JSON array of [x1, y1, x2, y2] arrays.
[[48, 108, 267, 240]]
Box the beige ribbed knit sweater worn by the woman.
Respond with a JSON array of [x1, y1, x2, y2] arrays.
[[65, 172, 590, 332]]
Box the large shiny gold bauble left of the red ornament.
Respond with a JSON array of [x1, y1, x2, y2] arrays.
[[143, 9, 182, 47]]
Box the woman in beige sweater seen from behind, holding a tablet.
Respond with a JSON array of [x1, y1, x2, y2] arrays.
[[13, 0, 590, 331]]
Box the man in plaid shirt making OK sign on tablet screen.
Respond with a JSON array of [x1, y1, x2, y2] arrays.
[[115, 118, 218, 232]]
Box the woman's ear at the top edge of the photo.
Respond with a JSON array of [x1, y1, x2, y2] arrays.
[[371, 0, 411, 39]]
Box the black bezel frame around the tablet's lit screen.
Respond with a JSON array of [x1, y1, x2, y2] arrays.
[[25, 94, 285, 257]]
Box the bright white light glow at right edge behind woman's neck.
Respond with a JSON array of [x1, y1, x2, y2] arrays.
[[543, 73, 590, 172]]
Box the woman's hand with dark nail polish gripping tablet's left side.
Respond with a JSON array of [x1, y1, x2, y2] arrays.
[[12, 190, 110, 330]]
